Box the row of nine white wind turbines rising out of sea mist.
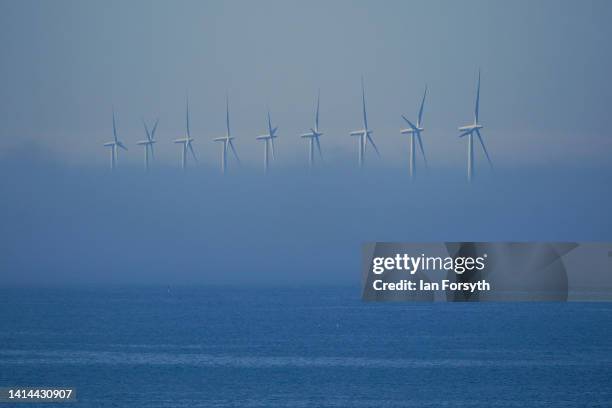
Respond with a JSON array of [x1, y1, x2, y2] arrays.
[[104, 70, 493, 182]]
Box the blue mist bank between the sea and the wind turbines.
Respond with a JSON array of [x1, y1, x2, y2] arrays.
[[0, 155, 612, 285]]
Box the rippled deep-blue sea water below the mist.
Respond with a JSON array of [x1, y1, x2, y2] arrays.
[[0, 287, 612, 407]]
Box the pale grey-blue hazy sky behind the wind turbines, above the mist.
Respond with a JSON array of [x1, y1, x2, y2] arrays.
[[0, 0, 612, 167]]
